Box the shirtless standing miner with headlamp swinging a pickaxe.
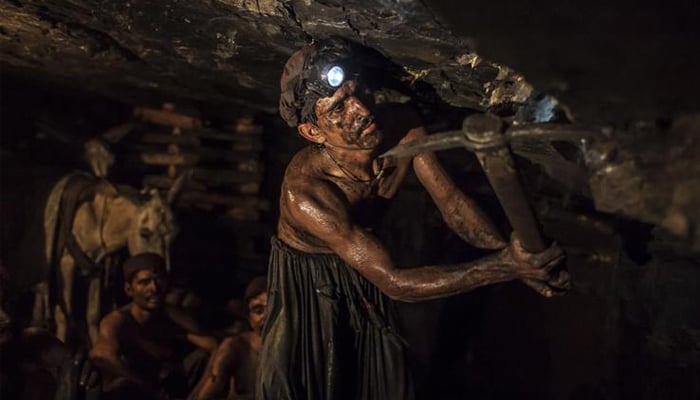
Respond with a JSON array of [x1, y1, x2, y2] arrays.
[[257, 39, 563, 399]]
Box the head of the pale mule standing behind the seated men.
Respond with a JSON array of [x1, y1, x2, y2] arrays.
[[128, 189, 178, 270]]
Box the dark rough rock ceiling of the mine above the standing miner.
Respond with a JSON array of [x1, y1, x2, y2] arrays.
[[0, 0, 700, 248]]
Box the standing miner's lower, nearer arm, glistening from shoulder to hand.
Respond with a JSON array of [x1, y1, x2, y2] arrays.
[[286, 180, 561, 301]]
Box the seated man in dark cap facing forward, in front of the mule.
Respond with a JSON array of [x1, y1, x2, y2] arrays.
[[91, 253, 217, 400]]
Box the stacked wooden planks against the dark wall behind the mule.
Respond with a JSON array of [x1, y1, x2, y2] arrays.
[[135, 107, 269, 221]]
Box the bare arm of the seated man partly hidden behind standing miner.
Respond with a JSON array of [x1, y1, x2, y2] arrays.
[[189, 338, 237, 400]]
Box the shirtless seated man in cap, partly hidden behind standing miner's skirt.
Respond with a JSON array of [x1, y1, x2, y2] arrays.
[[190, 276, 267, 400]]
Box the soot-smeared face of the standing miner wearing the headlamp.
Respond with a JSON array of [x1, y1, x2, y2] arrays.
[[316, 80, 382, 149]]
